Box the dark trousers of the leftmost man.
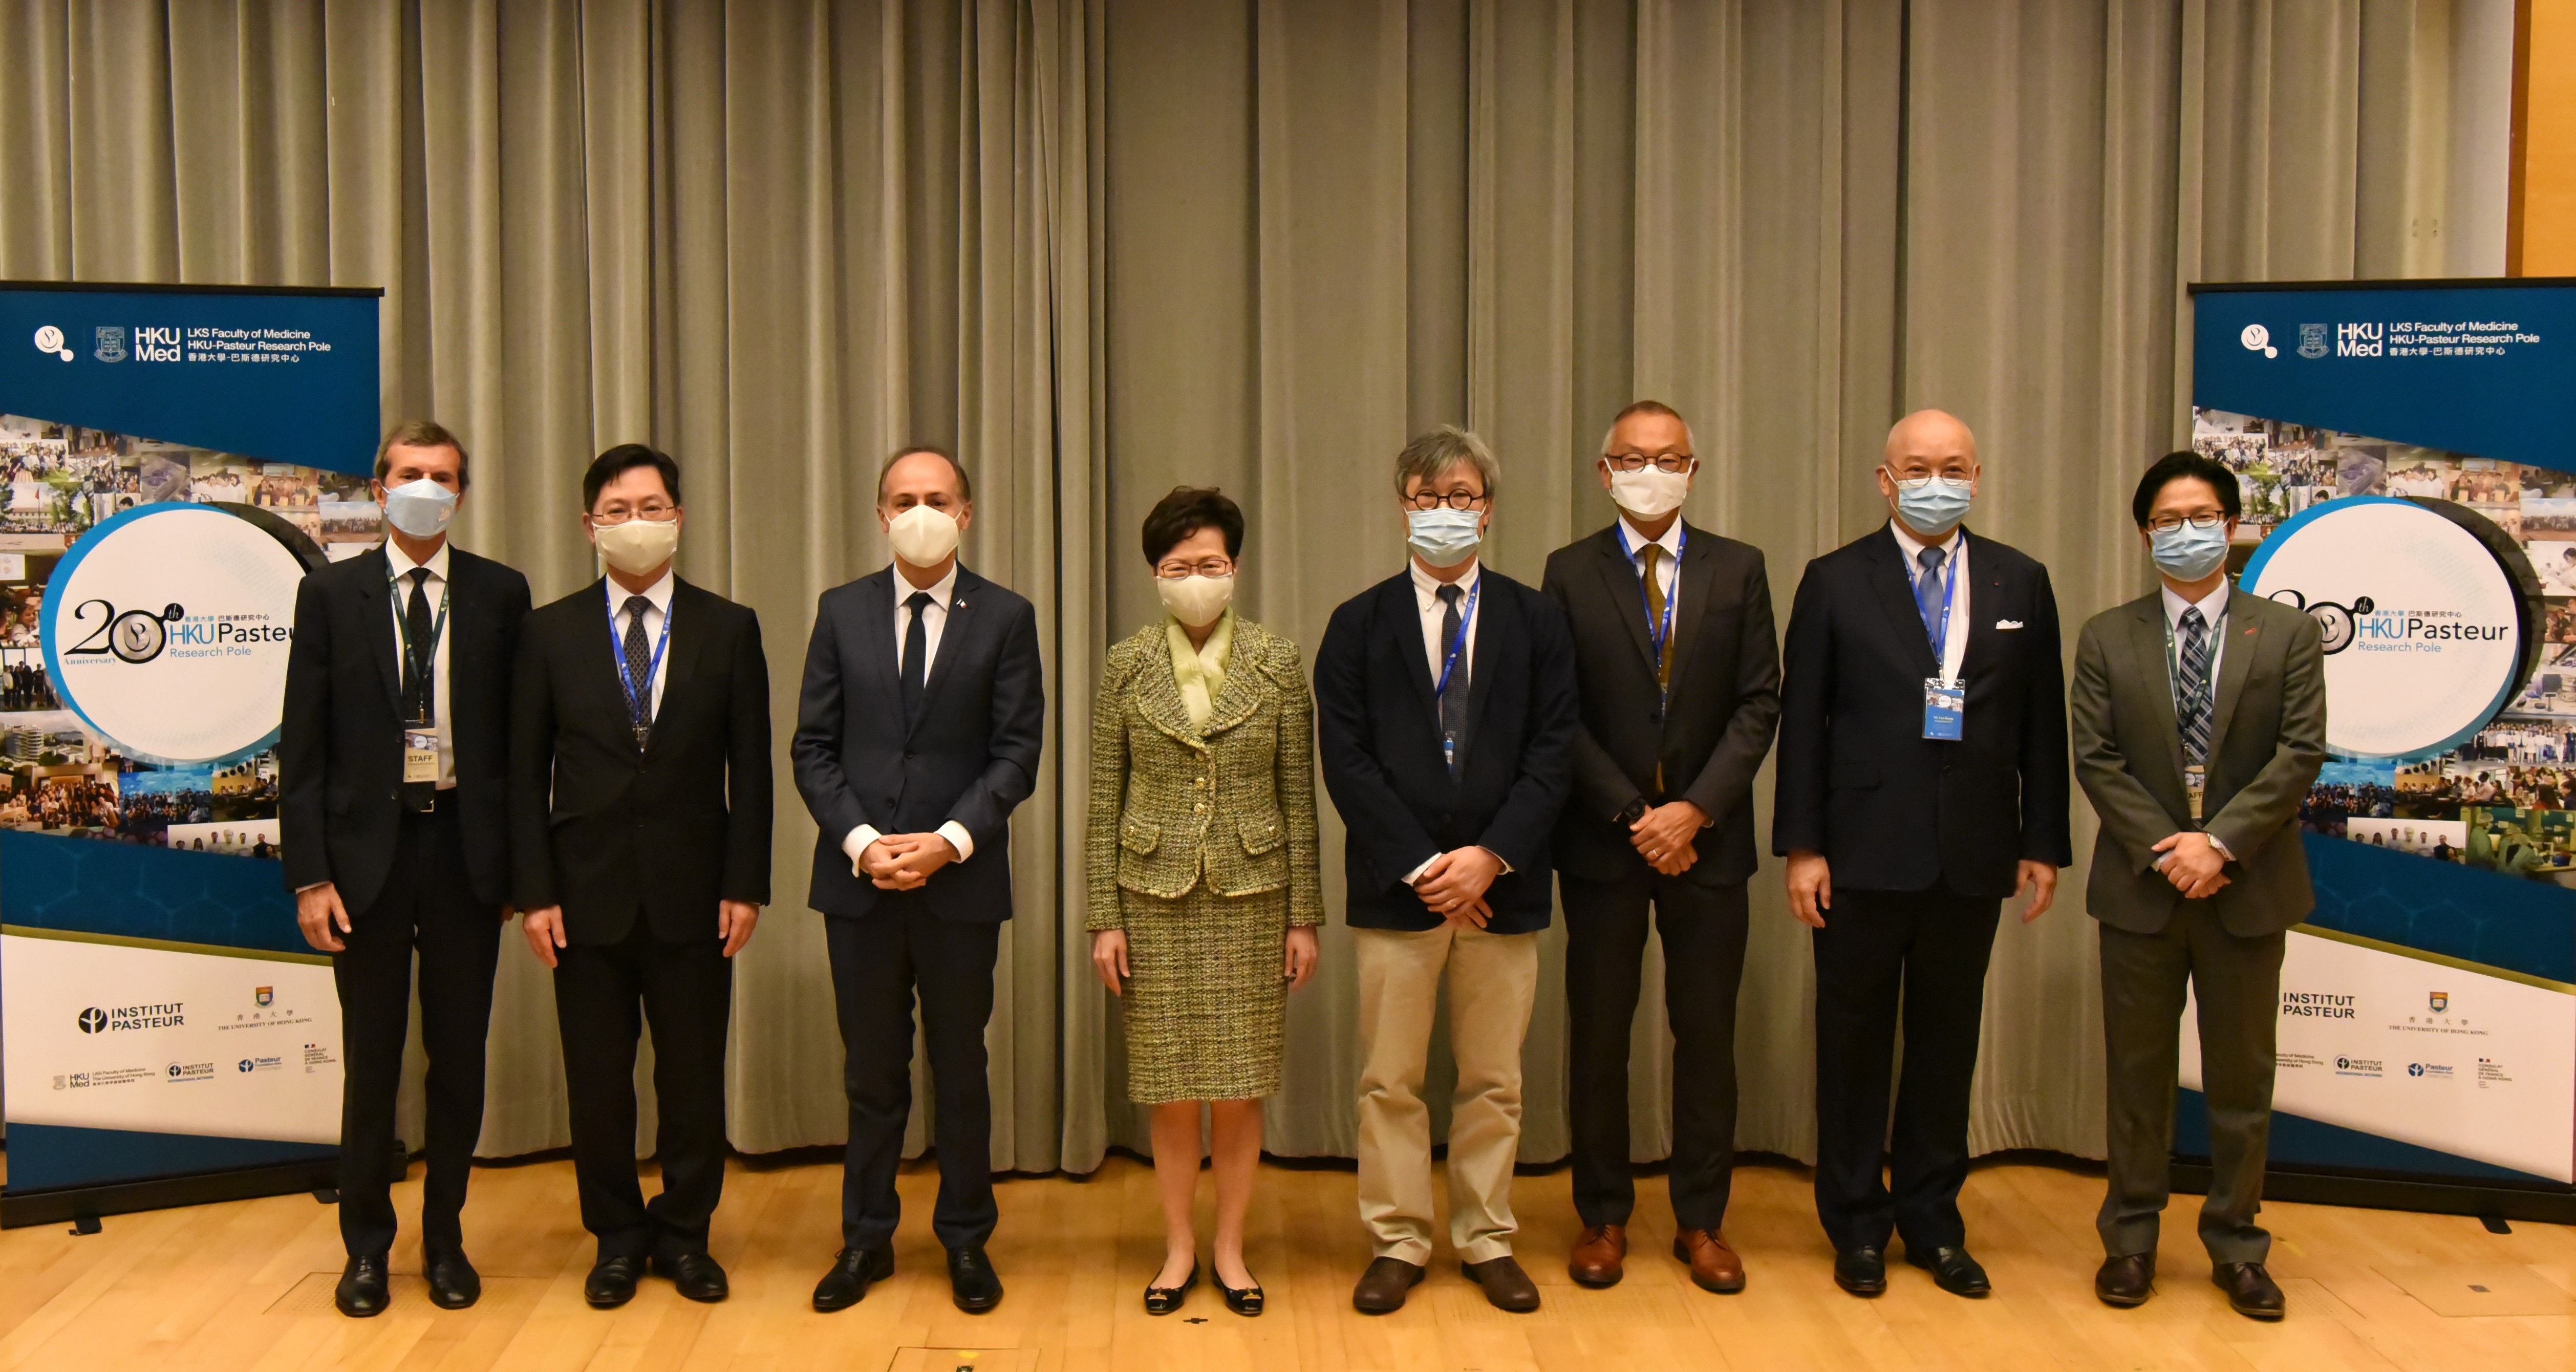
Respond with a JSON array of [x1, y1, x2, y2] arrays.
[[330, 808, 500, 1256]]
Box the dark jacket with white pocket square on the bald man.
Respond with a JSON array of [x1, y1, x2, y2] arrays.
[[1772, 525, 2074, 898]]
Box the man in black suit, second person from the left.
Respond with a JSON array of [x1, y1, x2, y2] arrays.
[[510, 443, 770, 1310]]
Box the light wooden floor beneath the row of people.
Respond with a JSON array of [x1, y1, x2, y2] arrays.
[[0, 1159, 2576, 1372]]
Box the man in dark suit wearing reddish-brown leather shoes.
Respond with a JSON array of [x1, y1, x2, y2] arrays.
[[1543, 399, 1780, 1292]]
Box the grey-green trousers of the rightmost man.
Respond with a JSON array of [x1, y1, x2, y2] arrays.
[[2094, 901, 2287, 1261]]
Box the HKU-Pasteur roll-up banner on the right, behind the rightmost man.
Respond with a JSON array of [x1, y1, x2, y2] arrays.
[[2174, 281, 2576, 1220]]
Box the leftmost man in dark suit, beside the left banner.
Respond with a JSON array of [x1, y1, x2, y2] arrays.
[[278, 420, 528, 1318]]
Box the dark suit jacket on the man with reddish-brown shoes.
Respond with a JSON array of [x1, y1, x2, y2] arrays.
[[1543, 523, 1780, 886]]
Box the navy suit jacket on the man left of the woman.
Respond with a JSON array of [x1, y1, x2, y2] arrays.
[[788, 566, 1046, 924]]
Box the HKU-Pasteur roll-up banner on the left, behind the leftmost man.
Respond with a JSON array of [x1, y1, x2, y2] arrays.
[[0, 283, 381, 1225]]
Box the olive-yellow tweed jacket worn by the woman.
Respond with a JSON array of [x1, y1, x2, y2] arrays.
[[1084, 618, 1324, 929]]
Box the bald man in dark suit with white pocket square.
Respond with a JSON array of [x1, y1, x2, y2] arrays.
[[1772, 409, 2074, 1297]]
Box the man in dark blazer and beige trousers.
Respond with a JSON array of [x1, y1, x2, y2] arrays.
[[1314, 427, 1577, 1315]]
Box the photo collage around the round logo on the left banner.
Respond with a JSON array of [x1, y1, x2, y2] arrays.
[[0, 415, 384, 857]]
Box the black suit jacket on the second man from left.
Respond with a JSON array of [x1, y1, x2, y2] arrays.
[[510, 582, 773, 945]]
